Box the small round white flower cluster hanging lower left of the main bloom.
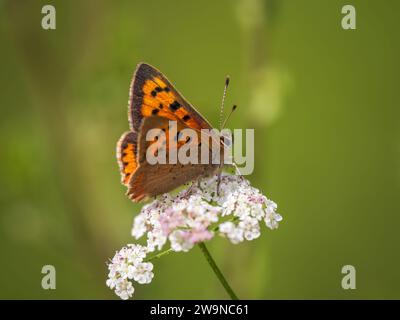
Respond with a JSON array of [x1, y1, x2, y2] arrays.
[[106, 244, 154, 300]]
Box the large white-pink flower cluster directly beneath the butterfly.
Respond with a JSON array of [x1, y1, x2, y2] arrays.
[[132, 175, 282, 251]]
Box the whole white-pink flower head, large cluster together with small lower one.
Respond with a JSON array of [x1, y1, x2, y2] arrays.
[[107, 175, 282, 299]]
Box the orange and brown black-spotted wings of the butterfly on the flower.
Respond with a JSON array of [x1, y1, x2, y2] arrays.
[[117, 63, 230, 202]]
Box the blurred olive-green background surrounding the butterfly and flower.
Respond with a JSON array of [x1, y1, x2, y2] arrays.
[[0, 0, 400, 299]]
